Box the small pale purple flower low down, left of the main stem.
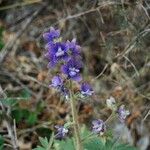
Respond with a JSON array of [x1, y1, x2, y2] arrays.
[[55, 125, 69, 139]]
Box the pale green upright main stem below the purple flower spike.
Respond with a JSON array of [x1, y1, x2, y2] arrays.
[[70, 91, 83, 150]]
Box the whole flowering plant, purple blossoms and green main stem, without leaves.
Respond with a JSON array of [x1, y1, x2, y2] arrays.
[[39, 27, 137, 150]]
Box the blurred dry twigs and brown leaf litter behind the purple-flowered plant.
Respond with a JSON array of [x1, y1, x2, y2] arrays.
[[0, 0, 150, 150]]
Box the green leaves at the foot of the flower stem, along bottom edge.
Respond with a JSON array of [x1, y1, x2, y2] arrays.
[[34, 127, 136, 150]]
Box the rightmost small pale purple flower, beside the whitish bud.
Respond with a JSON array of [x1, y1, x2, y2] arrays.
[[117, 105, 130, 123]]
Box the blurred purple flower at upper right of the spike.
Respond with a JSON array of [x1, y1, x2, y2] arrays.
[[66, 39, 81, 56]]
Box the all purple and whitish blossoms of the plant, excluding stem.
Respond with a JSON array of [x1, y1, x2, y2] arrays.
[[43, 27, 129, 139]]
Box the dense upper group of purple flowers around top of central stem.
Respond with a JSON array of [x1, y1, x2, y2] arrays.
[[43, 27, 93, 97]]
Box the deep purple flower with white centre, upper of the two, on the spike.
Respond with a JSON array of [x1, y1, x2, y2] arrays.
[[46, 43, 69, 67]]
